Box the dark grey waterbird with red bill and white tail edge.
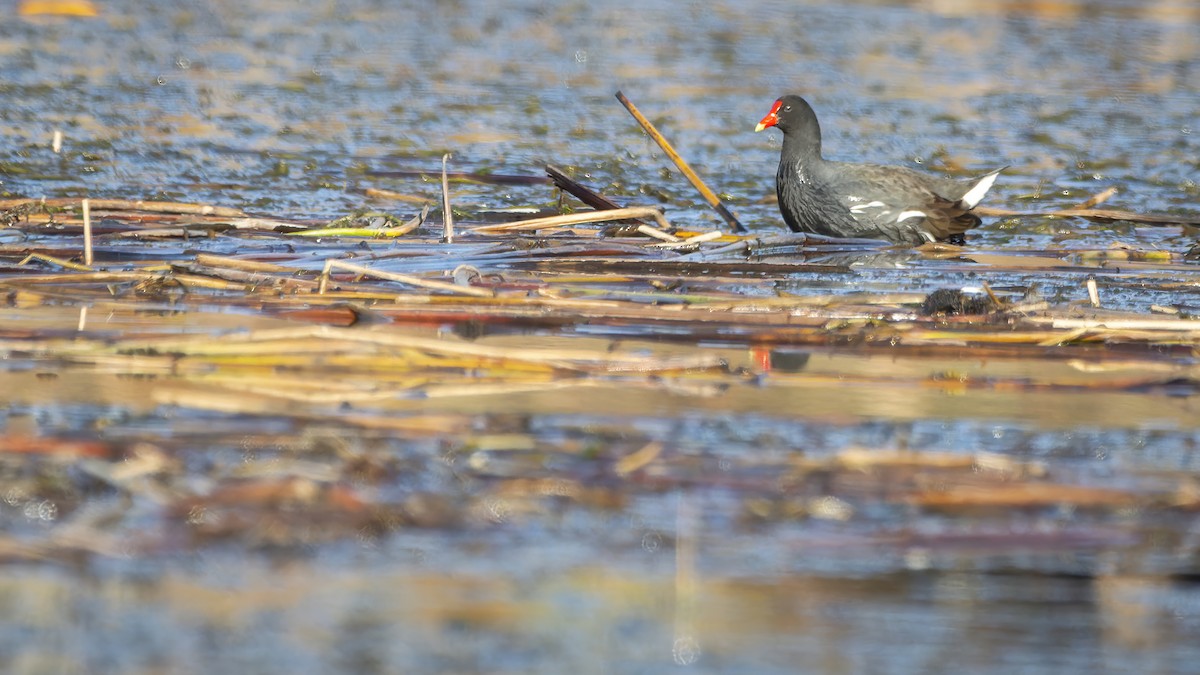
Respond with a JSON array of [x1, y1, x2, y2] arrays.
[[755, 95, 1003, 245]]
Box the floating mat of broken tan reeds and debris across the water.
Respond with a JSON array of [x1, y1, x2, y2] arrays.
[[0, 190, 1200, 577]]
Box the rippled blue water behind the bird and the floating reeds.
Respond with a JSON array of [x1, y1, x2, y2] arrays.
[[0, 1, 1200, 235]]
